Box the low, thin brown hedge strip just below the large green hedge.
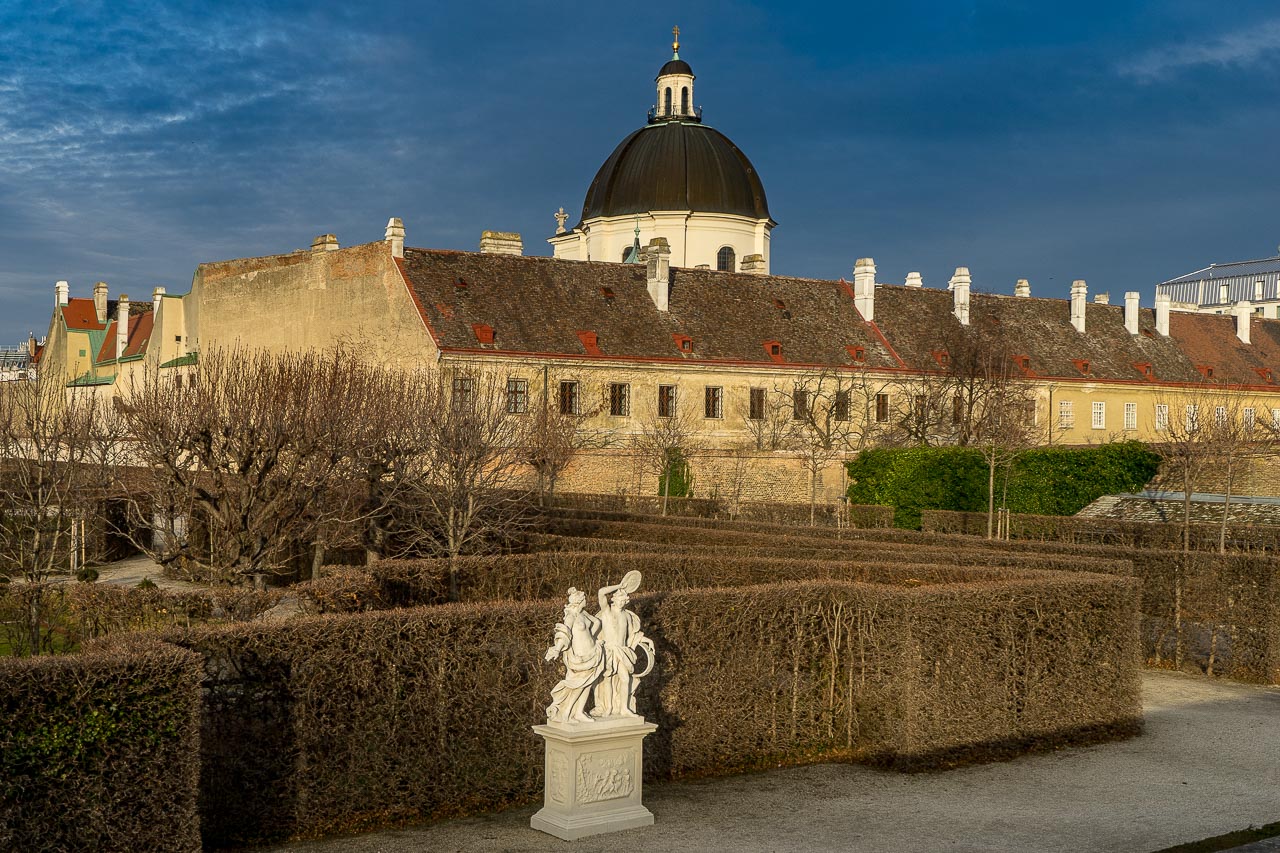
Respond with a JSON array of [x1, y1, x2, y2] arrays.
[[920, 510, 1280, 552]]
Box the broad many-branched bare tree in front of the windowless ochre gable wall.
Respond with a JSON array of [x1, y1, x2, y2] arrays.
[[120, 350, 367, 585]]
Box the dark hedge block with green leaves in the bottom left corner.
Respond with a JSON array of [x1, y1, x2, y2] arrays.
[[0, 638, 204, 853]]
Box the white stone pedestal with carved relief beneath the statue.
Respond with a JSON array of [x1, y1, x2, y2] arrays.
[[529, 717, 658, 841]]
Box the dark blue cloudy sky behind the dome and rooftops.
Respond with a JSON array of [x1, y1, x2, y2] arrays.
[[0, 0, 1280, 345]]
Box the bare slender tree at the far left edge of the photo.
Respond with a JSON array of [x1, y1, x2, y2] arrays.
[[0, 374, 119, 654]]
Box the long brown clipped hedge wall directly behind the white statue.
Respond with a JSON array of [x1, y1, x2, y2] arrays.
[[169, 567, 1140, 847]]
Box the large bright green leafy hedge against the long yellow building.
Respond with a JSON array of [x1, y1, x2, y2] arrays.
[[846, 442, 1160, 529]]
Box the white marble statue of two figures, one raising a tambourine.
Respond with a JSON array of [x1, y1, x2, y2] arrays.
[[545, 571, 654, 725]]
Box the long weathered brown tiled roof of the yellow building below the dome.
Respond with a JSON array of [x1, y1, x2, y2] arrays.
[[391, 248, 1280, 384]]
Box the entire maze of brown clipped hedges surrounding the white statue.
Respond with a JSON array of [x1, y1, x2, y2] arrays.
[[0, 508, 1280, 849]]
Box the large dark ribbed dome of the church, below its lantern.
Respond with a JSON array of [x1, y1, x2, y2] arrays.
[[582, 122, 769, 219]]
